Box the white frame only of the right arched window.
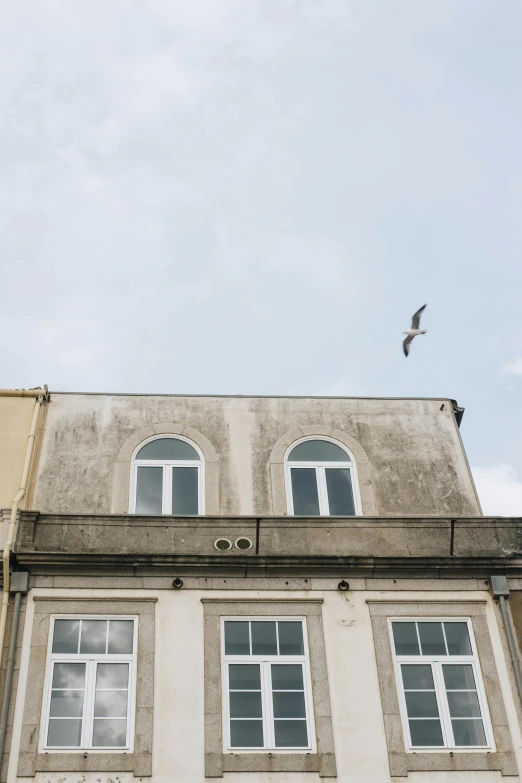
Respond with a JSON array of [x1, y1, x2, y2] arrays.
[[284, 435, 362, 517]]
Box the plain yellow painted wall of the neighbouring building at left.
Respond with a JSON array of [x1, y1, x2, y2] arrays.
[[0, 397, 34, 508]]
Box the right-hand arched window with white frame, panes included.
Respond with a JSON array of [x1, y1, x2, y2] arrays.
[[286, 437, 360, 517]]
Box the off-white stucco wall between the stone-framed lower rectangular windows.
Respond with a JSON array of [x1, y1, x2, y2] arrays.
[[8, 587, 522, 783]]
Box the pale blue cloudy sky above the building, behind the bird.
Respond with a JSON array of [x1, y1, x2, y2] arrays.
[[0, 0, 522, 516]]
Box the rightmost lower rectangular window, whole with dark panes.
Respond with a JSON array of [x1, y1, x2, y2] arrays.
[[391, 620, 491, 750]]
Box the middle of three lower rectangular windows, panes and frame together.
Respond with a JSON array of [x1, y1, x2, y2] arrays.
[[223, 619, 312, 751]]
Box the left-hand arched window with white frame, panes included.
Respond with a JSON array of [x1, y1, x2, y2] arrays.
[[131, 436, 204, 516]]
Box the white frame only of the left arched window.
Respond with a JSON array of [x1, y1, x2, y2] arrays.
[[129, 435, 205, 516]]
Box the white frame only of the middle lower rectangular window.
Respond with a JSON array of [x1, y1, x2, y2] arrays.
[[221, 615, 317, 754]]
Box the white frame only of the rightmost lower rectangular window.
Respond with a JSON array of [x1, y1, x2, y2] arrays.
[[388, 616, 495, 753]]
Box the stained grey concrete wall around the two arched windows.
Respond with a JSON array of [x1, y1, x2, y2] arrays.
[[32, 394, 480, 516]]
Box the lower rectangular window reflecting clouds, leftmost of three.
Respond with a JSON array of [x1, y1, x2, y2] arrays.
[[43, 617, 137, 750]]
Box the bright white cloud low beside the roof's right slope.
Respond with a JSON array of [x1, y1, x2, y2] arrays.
[[471, 463, 522, 517]]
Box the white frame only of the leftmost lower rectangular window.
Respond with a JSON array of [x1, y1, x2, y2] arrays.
[[38, 614, 138, 753]]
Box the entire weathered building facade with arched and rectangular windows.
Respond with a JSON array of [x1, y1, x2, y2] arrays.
[[2, 393, 522, 783]]
